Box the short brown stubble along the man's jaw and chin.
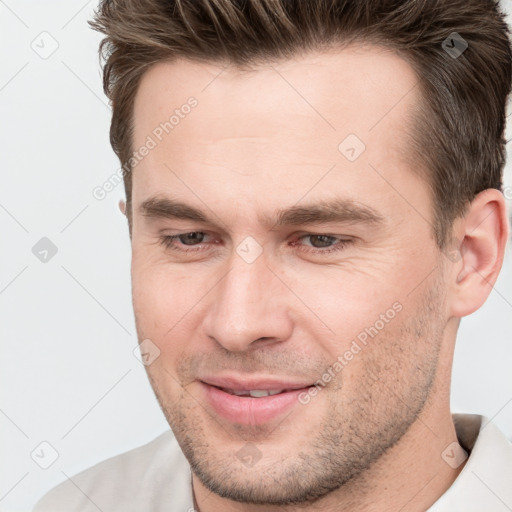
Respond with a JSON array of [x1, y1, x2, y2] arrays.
[[143, 276, 444, 506]]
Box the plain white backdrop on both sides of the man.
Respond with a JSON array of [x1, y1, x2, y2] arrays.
[[0, 0, 512, 512]]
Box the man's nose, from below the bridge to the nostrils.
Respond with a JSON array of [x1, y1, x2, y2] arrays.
[[203, 248, 292, 352]]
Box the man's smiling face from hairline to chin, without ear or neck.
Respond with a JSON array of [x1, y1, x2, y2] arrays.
[[132, 48, 447, 504]]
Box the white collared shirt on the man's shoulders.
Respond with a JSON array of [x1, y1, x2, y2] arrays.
[[33, 414, 512, 512]]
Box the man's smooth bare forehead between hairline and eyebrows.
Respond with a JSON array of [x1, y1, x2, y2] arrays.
[[133, 46, 426, 224]]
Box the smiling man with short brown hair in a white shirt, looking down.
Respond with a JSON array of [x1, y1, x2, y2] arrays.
[[36, 0, 512, 512]]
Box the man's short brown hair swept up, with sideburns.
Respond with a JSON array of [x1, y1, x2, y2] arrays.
[[90, 0, 512, 247]]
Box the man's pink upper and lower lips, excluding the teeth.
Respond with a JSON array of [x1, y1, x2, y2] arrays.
[[199, 377, 311, 425]]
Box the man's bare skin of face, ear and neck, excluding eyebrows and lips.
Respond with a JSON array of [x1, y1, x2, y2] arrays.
[[125, 47, 508, 512]]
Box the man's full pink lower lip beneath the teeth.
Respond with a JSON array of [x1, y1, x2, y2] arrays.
[[199, 381, 309, 425]]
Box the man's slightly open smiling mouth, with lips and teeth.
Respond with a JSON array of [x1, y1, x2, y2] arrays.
[[198, 379, 313, 425]]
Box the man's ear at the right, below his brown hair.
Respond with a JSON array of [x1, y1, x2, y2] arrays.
[[448, 189, 509, 317]]
